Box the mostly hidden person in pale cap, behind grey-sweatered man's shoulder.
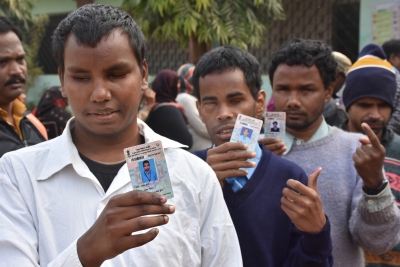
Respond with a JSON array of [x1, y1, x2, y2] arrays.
[[322, 51, 351, 129]]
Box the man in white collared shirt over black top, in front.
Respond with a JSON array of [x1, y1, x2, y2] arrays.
[[0, 4, 242, 267]]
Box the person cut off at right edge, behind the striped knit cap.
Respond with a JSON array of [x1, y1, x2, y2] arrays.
[[382, 39, 400, 134]]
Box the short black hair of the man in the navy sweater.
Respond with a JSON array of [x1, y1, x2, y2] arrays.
[[192, 46, 262, 102]]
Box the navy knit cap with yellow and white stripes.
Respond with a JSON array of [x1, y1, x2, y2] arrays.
[[343, 44, 397, 110]]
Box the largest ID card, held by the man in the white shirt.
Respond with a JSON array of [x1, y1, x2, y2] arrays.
[[124, 141, 174, 199]]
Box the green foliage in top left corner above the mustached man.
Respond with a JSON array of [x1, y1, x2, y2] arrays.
[[0, 0, 49, 89]]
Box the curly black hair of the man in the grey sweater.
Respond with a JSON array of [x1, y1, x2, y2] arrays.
[[268, 39, 337, 89]]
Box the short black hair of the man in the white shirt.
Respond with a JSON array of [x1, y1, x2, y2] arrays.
[[52, 4, 146, 74]]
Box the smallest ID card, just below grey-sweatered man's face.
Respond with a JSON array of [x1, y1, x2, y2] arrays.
[[264, 112, 286, 141]]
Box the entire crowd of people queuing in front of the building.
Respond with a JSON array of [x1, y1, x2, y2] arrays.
[[0, 4, 400, 267]]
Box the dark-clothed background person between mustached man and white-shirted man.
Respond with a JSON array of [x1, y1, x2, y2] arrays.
[[32, 86, 71, 140]]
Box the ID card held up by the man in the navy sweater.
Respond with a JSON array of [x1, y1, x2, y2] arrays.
[[230, 114, 263, 151]]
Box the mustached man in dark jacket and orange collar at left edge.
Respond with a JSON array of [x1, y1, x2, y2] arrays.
[[0, 17, 46, 157]]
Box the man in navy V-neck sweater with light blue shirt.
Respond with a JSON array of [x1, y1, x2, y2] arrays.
[[193, 46, 332, 267]]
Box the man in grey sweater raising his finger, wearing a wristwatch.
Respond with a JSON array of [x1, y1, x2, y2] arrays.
[[269, 39, 400, 267]]
